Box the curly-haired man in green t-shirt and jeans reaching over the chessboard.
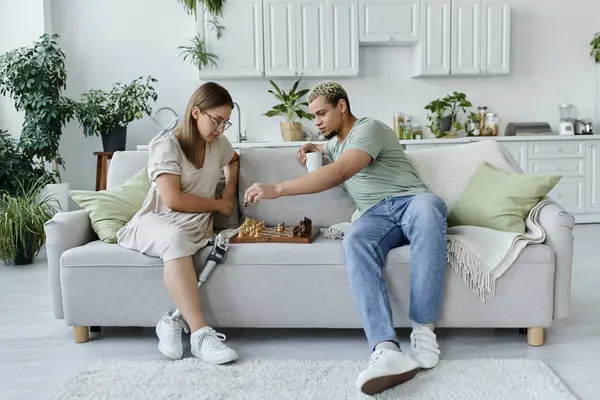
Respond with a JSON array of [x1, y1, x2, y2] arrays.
[[244, 81, 447, 395]]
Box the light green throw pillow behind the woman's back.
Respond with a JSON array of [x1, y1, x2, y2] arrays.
[[69, 168, 150, 243]]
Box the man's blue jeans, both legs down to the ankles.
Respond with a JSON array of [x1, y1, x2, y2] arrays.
[[343, 192, 447, 349]]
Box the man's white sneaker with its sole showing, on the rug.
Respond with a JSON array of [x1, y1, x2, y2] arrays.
[[356, 349, 420, 396]]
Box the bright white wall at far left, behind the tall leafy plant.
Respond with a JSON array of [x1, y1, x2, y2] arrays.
[[0, 0, 50, 136]]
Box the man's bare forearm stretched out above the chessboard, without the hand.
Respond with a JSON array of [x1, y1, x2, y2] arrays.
[[275, 164, 344, 196]]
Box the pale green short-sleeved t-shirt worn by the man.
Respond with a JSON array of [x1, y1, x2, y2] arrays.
[[325, 118, 428, 219]]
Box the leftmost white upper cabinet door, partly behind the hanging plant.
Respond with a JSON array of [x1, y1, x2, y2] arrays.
[[198, 0, 264, 79]]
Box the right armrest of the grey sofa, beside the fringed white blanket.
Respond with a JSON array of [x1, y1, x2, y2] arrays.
[[539, 202, 575, 319]]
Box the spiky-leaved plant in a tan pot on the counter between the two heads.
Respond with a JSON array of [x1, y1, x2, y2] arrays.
[[263, 79, 314, 142]]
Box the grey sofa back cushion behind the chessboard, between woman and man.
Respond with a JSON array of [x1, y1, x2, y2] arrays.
[[238, 147, 356, 227]]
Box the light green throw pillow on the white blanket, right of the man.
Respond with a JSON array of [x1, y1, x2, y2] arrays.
[[448, 162, 561, 233]]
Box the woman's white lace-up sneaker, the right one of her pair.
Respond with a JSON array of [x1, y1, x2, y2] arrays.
[[190, 326, 238, 364]]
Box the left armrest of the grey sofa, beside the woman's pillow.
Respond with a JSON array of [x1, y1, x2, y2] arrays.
[[44, 210, 97, 319]]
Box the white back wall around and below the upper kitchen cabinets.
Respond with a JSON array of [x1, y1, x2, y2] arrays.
[[15, 0, 600, 189]]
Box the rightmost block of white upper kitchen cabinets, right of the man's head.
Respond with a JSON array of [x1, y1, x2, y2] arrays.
[[412, 0, 510, 76]]
